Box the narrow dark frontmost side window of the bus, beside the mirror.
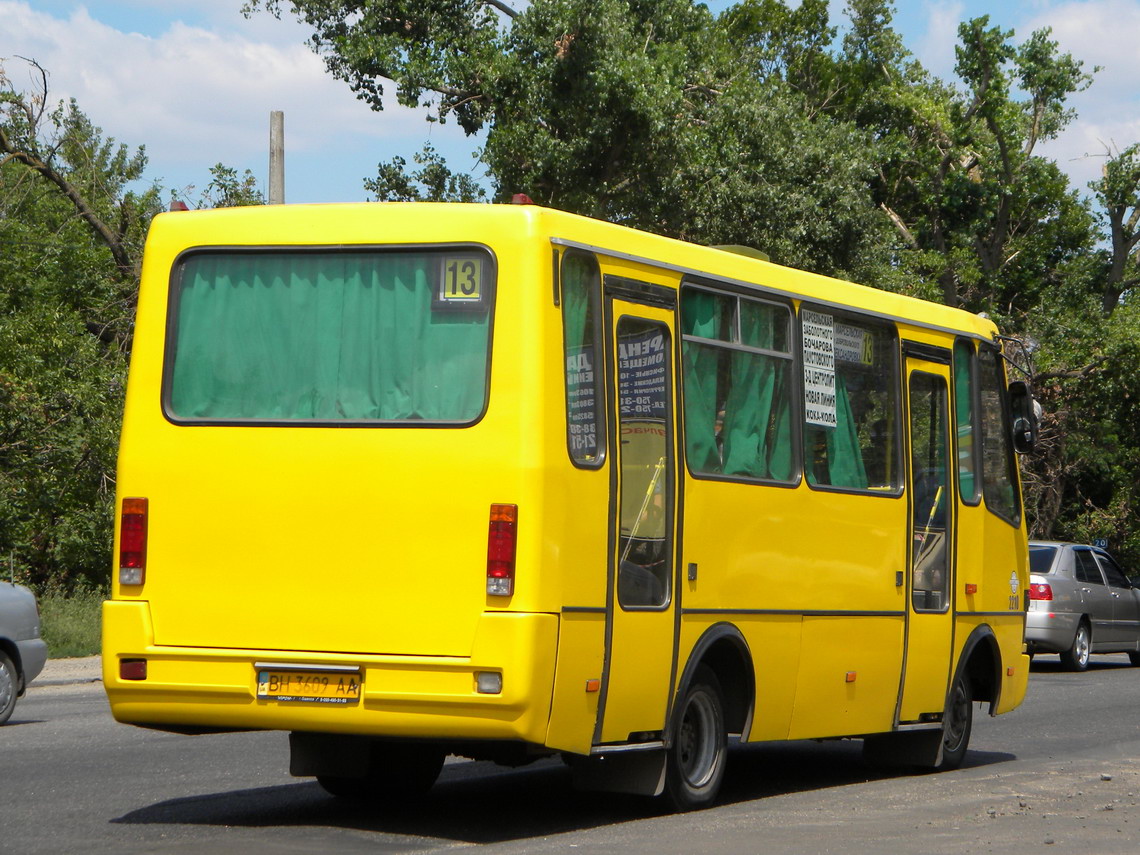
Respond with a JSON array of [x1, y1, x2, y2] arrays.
[[978, 348, 1021, 526]]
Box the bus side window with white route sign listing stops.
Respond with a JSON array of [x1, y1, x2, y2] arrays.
[[799, 307, 902, 495]]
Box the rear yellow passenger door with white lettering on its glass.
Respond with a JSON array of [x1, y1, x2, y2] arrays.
[[594, 291, 677, 743]]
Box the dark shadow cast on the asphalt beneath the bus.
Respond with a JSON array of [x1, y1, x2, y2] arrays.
[[112, 741, 1013, 844]]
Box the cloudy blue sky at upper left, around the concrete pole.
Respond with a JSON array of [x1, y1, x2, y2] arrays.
[[0, 0, 466, 198]]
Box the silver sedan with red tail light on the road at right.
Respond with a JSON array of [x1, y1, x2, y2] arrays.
[[1025, 540, 1140, 671]]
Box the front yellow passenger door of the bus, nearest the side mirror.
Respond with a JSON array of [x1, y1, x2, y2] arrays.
[[898, 352, 955, 723]]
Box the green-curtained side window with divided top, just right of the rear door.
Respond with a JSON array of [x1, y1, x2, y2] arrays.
[[681, 285, 797, 482]]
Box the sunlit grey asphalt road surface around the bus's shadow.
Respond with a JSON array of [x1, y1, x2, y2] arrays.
[[0, 657, 1140, 855]]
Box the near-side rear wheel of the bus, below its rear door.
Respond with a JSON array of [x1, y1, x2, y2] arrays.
[[665, 665, 728, 811]]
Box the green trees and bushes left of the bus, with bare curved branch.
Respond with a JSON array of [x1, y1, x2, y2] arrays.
[[0, 62, 260, 592]]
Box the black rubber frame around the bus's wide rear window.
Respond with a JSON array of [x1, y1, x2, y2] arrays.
[[161, 241, 499, 429]]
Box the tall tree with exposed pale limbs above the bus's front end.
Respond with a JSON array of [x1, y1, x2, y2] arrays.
[[834, 8, 1094, 316]]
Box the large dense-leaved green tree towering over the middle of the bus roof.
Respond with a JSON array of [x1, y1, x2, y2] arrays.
[[245, 0, 886, 276]]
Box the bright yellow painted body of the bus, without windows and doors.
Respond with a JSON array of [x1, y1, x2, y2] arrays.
[[104, 204, 1028, 754]]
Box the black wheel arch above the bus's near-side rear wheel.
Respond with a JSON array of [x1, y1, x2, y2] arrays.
[[666, 622, 756, 739]]
